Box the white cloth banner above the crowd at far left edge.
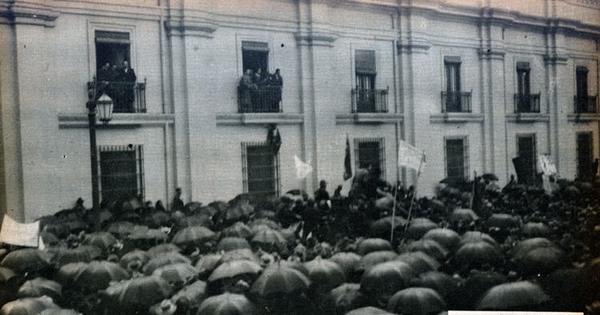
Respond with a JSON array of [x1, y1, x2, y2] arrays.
[[0, 214, 40, 247]]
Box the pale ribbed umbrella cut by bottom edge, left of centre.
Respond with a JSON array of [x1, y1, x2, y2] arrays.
[[197, 293, 260, 315]]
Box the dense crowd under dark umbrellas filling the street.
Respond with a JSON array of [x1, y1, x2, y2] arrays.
[[0, 182, 600, 315]]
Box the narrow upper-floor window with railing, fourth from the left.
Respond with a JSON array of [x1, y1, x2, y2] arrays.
[[442, 56, 471, 113]]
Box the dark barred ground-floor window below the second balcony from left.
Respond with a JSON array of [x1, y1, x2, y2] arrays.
[[242, 142, 279, 200]]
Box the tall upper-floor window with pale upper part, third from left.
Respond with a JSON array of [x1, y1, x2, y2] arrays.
[[354, 49, 377, 112]]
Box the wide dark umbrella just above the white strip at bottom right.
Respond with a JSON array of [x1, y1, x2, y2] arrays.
[[477, 281, 551, 311]]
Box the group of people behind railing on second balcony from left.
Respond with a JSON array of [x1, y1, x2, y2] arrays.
[[238, 68, 283, 112]]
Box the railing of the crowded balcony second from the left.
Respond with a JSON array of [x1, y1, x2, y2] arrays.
[[238, 86, 282, 113]]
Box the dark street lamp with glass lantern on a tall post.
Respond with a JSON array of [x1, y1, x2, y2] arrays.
[[86, 86, 113, 211]]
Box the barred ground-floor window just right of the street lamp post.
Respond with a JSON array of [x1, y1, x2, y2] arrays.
[[99, 145, 144, 202]]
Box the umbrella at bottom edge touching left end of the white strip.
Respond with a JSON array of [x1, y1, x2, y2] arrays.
[[387, 288, 447, 315]]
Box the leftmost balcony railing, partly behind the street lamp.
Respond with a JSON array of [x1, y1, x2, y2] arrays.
[[88, 79, 146, 113]]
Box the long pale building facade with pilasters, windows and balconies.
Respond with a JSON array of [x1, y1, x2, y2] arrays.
[[0, 0, 600, 221]]
